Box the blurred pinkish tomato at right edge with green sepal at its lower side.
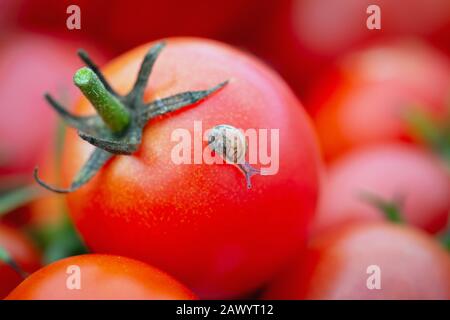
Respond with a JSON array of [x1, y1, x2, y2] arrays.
[[313, 144, 450, 232]]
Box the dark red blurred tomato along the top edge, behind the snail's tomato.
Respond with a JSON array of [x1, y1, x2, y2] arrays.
[[12, 0, 280, 52]]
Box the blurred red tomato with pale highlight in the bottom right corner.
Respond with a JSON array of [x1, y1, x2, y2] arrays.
[[265, 223, 450, 300]]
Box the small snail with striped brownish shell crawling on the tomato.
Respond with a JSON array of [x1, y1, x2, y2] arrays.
[[208, 124, 261, 189]]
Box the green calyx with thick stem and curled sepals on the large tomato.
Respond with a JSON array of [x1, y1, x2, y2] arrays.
[[34, 42, 228, 193]]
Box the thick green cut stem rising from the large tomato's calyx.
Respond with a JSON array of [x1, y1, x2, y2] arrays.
[[73, 67, 131, 133]]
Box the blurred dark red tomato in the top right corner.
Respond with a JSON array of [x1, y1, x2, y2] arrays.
[[259, 0, 450, 94]]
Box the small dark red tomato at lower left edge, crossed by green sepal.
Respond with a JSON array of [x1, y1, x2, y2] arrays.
[[0, 224, 40, 299]]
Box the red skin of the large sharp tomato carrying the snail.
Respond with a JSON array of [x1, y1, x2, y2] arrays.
[[64, 38, 321, 298]]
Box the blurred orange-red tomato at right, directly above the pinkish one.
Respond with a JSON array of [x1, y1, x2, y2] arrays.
[[310, 43, 450, 160]]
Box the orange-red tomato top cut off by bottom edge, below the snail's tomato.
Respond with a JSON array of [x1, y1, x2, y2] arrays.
[[6, 254, 195, 300]]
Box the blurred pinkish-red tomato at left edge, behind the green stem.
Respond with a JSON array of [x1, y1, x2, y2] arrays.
[[0, 33, 103, 178]]
